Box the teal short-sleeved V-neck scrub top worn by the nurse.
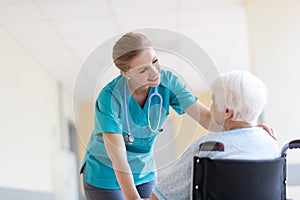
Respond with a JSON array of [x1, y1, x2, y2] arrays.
[[80, 70, 197, 189]]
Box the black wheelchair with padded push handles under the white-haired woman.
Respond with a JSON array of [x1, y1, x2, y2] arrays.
[[191, 140, 300, 200]]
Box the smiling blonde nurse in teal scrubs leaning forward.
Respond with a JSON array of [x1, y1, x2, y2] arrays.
[[81, 33, 210, 200]]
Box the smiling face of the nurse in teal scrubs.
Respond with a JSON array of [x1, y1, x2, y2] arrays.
[[125, 49, 160, 87]]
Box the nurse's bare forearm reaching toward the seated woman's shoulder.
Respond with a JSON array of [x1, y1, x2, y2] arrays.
[[185, 101, 211, 129]]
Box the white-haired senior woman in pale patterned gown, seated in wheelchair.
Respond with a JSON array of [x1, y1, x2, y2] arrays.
[[150, 71, 279, 200]]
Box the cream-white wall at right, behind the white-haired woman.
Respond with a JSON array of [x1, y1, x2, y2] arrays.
[[246, 0, 300, 198]]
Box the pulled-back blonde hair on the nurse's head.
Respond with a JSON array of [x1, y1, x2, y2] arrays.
[[112, 32, 152, 72]]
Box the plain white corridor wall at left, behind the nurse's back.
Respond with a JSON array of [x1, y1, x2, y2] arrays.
[[0, 27, 77, 199]]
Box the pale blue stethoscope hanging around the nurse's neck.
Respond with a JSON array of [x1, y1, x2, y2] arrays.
[[124, 81, 163, 144]]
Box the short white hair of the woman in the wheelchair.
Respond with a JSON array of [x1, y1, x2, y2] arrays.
[[212, 71, 267, 124]]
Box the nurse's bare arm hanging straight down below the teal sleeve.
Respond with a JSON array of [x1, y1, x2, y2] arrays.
[[103, 133, 140, 199]]
